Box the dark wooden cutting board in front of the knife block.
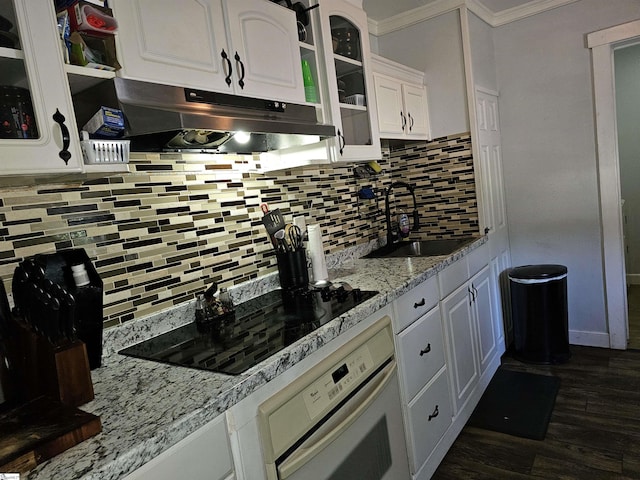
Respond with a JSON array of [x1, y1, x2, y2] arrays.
[[0, 397, 102, 473]]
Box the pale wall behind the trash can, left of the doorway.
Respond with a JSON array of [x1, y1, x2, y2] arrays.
[[493, 0, 640, 346]]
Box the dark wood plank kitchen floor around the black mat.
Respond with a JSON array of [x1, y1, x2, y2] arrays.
[[432, 346, 640, 480]]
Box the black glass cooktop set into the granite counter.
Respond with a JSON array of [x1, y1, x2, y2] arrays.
[[119, 287, 378, 375]]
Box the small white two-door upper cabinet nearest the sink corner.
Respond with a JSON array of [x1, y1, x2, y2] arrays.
[[372, 55, 431, 140]]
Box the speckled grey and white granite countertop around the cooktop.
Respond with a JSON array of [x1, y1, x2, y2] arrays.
[[25, 237, 486, 480]]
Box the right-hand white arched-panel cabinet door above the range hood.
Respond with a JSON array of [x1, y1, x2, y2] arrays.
[[225, 0, 305, 103]]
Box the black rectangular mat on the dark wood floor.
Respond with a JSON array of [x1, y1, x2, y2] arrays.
[[468, 368, 560, 440]]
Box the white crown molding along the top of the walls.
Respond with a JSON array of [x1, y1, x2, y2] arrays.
[[369, 0, 578, 36]]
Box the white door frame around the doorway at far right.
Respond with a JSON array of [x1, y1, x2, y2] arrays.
[[587, 20, 640, 350]]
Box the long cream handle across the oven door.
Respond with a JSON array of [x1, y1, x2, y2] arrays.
[[278, 360, 396, 480]]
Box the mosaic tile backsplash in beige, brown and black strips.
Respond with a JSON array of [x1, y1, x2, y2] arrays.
[[0, 133, 478, 327]]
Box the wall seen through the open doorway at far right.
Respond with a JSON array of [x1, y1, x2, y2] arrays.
[[614, 45, 640, 283]]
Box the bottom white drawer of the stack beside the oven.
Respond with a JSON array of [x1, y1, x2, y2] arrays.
[[408, 369, 452, 474]]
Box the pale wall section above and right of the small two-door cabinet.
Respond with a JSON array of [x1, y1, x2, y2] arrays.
[[377, 10, 469, 138]]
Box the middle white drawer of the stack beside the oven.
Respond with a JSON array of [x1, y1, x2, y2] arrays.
[[397, 307, 444, 402]]
